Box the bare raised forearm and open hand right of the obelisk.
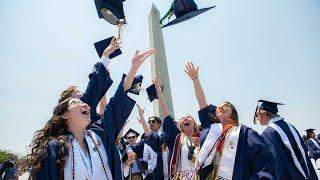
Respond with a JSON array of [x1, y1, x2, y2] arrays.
[[184, 62, 208, 109]]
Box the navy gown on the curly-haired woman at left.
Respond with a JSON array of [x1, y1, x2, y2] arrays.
[[36, 81, 135, 180]]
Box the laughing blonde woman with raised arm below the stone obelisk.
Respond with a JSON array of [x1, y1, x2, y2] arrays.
[[153, 79, 200, 180]]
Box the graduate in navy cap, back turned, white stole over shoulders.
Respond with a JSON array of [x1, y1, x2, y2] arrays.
[[254, 100, 318, 180]]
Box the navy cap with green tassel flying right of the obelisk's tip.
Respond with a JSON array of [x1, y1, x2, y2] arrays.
[[163, 0, 215, 27]]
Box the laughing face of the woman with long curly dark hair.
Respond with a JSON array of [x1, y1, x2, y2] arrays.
[[64, 98, 90, 128]]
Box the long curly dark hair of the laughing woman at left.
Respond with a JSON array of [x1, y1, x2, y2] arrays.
[[20, 98, 71, 179]]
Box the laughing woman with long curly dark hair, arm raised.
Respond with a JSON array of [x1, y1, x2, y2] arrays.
[[22, 50, 154, 180]]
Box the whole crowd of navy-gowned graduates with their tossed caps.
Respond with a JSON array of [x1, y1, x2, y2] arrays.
[[0, 0, 320, 180]]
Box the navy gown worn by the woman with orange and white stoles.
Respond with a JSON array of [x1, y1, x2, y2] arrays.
[[198, 105, 276, 180]]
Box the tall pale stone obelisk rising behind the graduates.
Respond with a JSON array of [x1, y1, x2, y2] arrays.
[[149, 4, 174, 119]]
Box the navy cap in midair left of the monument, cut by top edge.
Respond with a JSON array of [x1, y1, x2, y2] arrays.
[[94, 0, 125, 25]]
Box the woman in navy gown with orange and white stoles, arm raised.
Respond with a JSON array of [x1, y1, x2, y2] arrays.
[[185, 62, 276, 180]]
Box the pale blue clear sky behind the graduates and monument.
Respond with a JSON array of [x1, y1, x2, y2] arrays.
[[0, 0, 320, 154]]
